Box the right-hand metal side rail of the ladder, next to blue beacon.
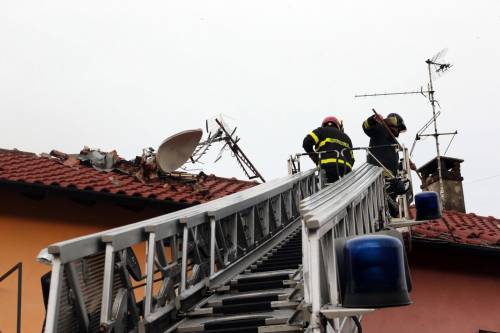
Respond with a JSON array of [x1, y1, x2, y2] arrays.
[[300, 164, 386, 333]]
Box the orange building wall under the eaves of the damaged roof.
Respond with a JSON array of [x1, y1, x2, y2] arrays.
[[0, 189, 170, 333]]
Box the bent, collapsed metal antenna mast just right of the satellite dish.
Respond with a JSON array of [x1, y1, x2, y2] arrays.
[[190, 115, 266, 183]]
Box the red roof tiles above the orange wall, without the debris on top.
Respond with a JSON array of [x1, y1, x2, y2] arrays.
[[0, 149, 258, 204]]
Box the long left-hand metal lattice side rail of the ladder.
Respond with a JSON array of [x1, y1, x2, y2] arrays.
[[45, 170, 316, 332]]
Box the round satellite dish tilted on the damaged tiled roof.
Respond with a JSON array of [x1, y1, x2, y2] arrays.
[[156, 128, 203, 172]]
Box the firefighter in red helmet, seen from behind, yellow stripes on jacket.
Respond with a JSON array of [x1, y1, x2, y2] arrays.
[[302, 116, 354, 183]]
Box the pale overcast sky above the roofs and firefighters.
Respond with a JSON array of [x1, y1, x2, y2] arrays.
[[0, 0, 500, 217]]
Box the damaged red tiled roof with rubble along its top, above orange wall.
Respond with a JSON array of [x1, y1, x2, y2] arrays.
[[0, 148, 258, 204]]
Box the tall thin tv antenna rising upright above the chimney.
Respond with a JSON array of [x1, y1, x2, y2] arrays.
[[354, 49, 458, 202]]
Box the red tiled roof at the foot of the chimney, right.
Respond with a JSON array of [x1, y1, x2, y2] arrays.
[[410, 207, 500, 248]]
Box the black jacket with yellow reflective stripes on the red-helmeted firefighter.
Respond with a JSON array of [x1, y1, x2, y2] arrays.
[[302, 126, 354, 171]]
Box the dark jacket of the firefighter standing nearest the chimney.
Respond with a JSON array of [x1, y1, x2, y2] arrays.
[[363, 116, 399, 175]]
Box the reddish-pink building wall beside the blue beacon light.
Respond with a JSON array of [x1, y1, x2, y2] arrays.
[[363, 243, 500, 333]]
